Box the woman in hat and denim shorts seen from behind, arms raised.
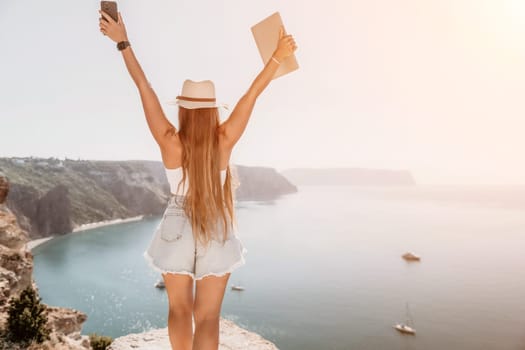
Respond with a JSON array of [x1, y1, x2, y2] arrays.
[[99, 10, 297, 350]]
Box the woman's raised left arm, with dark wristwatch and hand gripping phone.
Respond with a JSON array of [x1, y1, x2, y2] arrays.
[[99, 10, 177, 148]]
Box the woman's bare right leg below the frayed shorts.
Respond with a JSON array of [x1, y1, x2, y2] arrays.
[[189, 273, 230, 350]]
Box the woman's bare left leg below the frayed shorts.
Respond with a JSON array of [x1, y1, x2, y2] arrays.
[[162, 273, 193, 350]]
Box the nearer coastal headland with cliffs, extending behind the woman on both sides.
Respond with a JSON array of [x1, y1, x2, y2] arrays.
[[0, 157, 297, 239]]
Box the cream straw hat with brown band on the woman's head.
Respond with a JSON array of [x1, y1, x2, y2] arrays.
[[167, 79, 228, 109]]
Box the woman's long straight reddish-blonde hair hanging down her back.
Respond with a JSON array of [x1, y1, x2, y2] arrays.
[[173, 106, 239, 244]]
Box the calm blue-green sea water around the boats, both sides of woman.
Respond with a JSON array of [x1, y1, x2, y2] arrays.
[[33, 186, 525, 350]]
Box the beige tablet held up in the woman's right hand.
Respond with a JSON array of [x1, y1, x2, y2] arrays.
[[251, 12, 299, 79]]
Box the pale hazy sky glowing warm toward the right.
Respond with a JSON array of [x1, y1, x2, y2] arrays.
[[0, 0, 525, 184]]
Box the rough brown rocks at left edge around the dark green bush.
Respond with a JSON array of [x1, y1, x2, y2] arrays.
[[0, 173, 90, 350]]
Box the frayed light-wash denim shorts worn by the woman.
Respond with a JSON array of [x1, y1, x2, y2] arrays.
[[143, 195, 248, 280]]
